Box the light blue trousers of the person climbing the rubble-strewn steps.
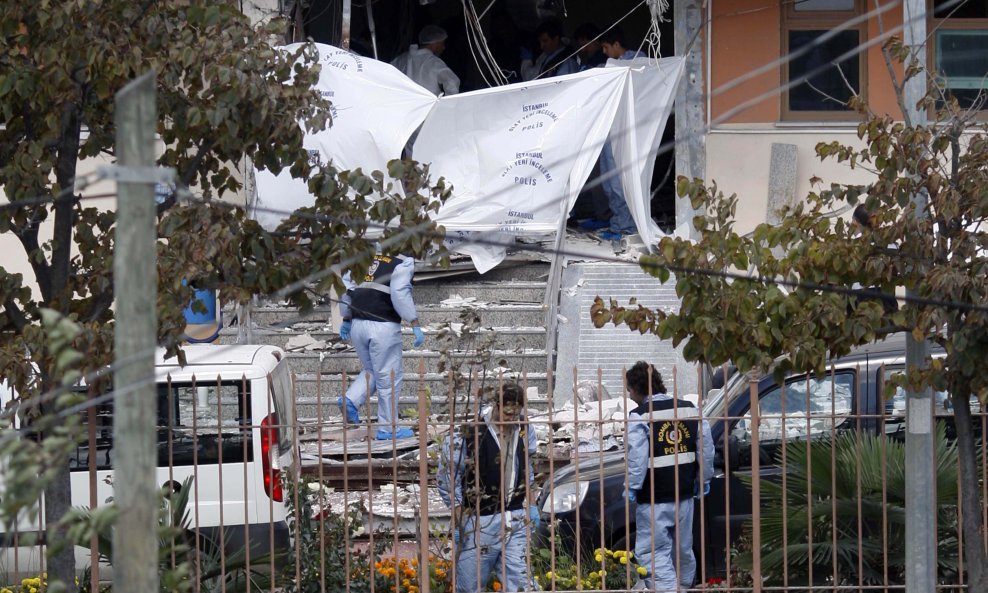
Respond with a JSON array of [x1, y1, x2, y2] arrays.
[[346, 319, 404, 432]]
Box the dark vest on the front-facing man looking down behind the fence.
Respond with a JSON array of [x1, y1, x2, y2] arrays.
[[463, 420, 528, 515]]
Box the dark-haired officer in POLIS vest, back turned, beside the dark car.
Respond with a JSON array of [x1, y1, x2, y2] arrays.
[[626, 361, 714, 591]]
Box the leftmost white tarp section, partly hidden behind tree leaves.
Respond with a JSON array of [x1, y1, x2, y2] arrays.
[[253, 43, 436, 229]]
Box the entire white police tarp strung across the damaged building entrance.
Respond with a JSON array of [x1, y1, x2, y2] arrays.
[[253, 44, 683, 272]]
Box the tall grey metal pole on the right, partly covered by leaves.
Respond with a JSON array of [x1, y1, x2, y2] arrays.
[[902, 0, 936, 593]]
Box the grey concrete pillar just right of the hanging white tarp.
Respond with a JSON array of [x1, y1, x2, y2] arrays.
[[673, 0, 709, 239]]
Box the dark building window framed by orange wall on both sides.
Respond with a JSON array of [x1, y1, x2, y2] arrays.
[[782, 0, 866, 120]]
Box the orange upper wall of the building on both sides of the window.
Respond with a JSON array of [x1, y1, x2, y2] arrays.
[[708, 0, 902, 126]]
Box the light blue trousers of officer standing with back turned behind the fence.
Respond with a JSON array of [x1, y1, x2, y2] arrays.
[[635, 497, 696, 593]]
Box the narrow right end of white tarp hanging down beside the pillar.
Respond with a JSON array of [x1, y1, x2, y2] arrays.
[[607, 57, 685, 245]]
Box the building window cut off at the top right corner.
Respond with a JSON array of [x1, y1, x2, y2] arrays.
[[930, 0, 988, 110]]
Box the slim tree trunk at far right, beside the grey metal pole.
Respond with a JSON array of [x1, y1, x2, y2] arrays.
[[950, 385, 988, 593]]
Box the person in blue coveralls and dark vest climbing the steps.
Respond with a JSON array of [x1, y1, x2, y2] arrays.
[[337, 253, 425, 440]]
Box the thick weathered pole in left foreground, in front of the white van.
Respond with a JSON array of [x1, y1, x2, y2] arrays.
[[113, 71, 158, 593]]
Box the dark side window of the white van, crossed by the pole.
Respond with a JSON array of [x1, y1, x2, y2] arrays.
[[69, 380, 253, 471]]
